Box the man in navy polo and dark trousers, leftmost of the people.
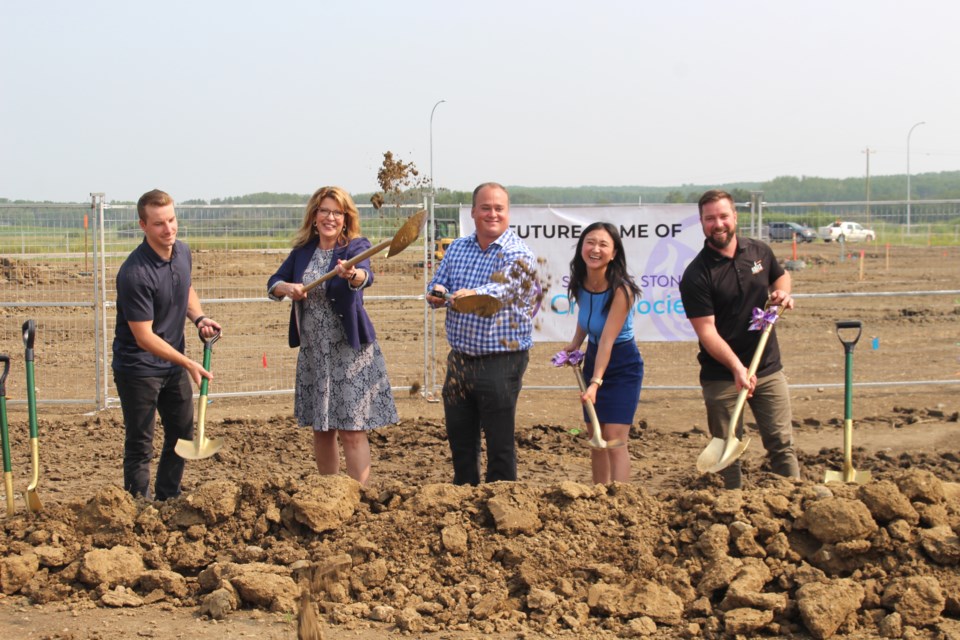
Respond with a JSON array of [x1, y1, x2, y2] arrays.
[[113, 189, 220, 500]]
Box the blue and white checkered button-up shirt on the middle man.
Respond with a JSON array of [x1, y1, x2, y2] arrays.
[[430, 229, 539, 356]]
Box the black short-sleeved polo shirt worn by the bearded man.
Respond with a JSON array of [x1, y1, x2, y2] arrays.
[[680, 236, 784, 380]]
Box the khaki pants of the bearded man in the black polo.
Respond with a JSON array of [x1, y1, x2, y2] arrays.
[[701, 370, 800, 489]]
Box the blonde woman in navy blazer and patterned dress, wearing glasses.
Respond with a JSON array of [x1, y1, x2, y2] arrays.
[[267, 187, 399, 485]]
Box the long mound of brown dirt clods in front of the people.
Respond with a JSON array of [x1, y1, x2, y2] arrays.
[[0, 458, 960, 638]]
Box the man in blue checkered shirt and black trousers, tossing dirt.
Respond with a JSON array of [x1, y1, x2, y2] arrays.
[[426, 182, 539, 485]]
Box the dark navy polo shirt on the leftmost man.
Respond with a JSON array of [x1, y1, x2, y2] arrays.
[[113, 239, 193, 377]]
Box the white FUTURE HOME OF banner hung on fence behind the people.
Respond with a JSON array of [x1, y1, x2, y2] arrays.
[[460, 204, 703, 342]]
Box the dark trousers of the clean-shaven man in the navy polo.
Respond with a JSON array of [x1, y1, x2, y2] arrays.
[[113, 367, 193, 500]]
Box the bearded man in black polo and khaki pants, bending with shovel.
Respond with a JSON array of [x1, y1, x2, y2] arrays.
[[680, 189, 800, 489]]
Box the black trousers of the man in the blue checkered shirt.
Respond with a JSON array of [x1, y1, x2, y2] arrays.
[[443, 351, 530, 486]]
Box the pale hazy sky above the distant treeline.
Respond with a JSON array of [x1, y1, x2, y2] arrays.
[[0, 0, 960, 201]]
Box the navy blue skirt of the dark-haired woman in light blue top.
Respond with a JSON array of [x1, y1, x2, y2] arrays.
[[583, 340, 643, 424]]
